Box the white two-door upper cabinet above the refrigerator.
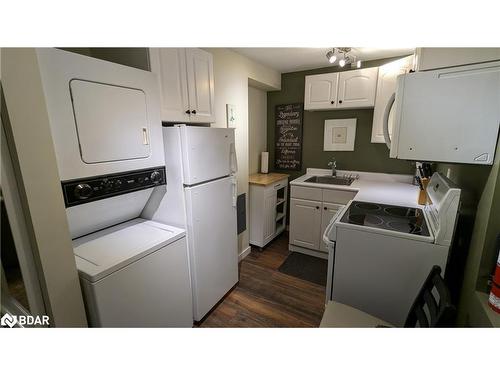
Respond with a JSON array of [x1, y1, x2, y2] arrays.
[[150, 48, 215, 123]]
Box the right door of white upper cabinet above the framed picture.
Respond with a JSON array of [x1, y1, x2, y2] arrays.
[[337, 68, 378, 109]]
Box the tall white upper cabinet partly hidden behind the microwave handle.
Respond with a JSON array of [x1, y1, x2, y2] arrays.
[[372, 55, 413, 143]]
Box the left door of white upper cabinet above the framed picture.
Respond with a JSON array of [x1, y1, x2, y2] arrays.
[[304, 73, 339, 110]]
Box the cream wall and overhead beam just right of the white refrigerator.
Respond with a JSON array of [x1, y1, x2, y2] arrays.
[[207, 48, 281, 254]]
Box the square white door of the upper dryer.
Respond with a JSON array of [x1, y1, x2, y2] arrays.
[[70, 79, 151, 164]]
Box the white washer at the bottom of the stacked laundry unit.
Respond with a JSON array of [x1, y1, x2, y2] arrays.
[[73, 219, 193, 327]]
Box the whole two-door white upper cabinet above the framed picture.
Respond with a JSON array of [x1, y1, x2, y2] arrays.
[[304, 68, 378, 110]]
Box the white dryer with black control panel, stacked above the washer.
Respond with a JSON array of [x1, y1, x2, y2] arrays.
[[36, 48, 165, 238]]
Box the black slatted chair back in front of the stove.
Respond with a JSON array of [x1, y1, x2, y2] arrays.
[[405, 266, 456, 328]]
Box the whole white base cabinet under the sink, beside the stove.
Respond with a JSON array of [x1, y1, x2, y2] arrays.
[[289, 186, 356, 258]]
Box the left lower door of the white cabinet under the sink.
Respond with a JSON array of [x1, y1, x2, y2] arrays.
[[290, 199, 321, 250]]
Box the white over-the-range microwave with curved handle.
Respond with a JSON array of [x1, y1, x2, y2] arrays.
[[384, 61, 500, 164]]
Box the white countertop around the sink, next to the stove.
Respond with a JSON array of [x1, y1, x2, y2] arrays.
[[290, 168, 421, 207]]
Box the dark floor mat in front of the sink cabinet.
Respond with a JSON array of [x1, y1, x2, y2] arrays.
[[278, 252, 328, 286]]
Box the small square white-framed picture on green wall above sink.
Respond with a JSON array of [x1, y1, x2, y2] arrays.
[[323, 118, 357, 151]]
